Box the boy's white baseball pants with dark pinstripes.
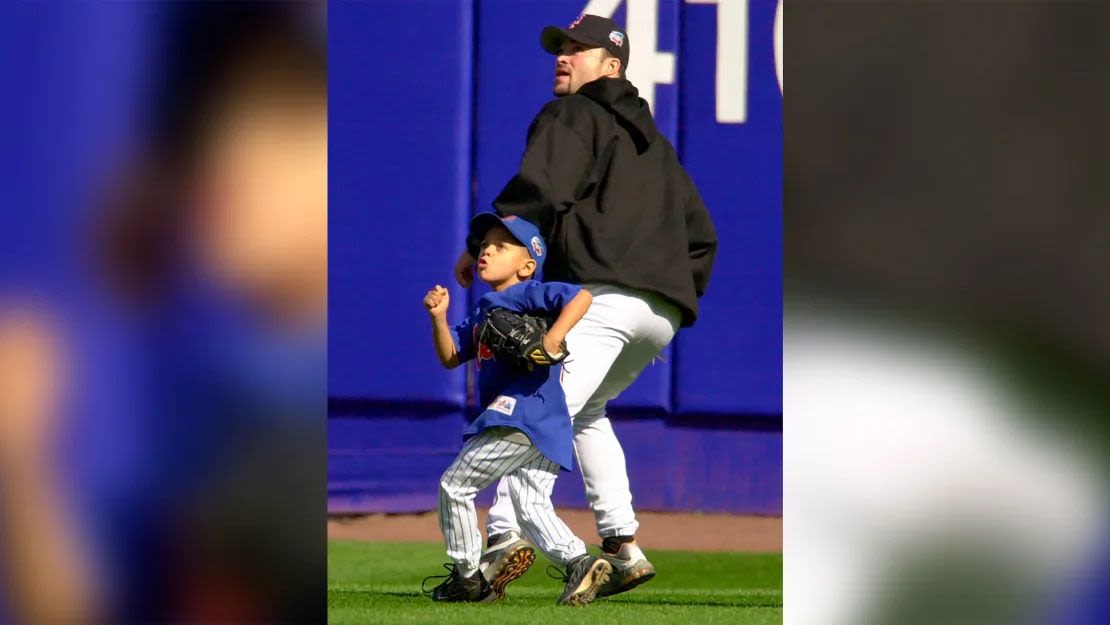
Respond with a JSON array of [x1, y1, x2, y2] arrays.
[[440, 427, 586, 576]]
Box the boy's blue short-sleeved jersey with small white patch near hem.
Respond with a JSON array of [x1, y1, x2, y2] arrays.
[[452, 280, 582, 471]]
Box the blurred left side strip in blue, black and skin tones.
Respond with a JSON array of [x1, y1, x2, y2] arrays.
[[0, 2, 327, 625]]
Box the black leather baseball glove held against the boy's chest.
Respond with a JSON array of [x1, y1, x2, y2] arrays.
[[478, 308, 567, 371]]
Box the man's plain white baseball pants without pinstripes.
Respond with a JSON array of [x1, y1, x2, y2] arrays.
[[486, 284, 682, 538]]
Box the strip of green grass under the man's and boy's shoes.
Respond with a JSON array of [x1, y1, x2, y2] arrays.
[[327, 541, 783, 625]]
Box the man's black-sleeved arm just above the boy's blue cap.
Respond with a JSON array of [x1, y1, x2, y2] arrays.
[[493, 103, 594, 238]]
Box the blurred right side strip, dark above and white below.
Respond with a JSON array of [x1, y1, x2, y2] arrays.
[[783, 2, 1110, 625]]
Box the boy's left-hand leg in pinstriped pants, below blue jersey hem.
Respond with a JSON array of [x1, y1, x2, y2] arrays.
[[438, 429, 539, 577]]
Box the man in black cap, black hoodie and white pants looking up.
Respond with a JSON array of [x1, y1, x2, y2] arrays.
[[455, 14, 717, 596]]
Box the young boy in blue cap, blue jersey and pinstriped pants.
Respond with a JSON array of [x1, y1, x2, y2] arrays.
[[424, 213, 612, 605]]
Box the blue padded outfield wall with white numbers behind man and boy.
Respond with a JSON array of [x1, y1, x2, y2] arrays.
[[329, 0, 783, 515]]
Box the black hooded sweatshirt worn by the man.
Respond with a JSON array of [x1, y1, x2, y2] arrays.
[[493, 78, 717, 327]]
